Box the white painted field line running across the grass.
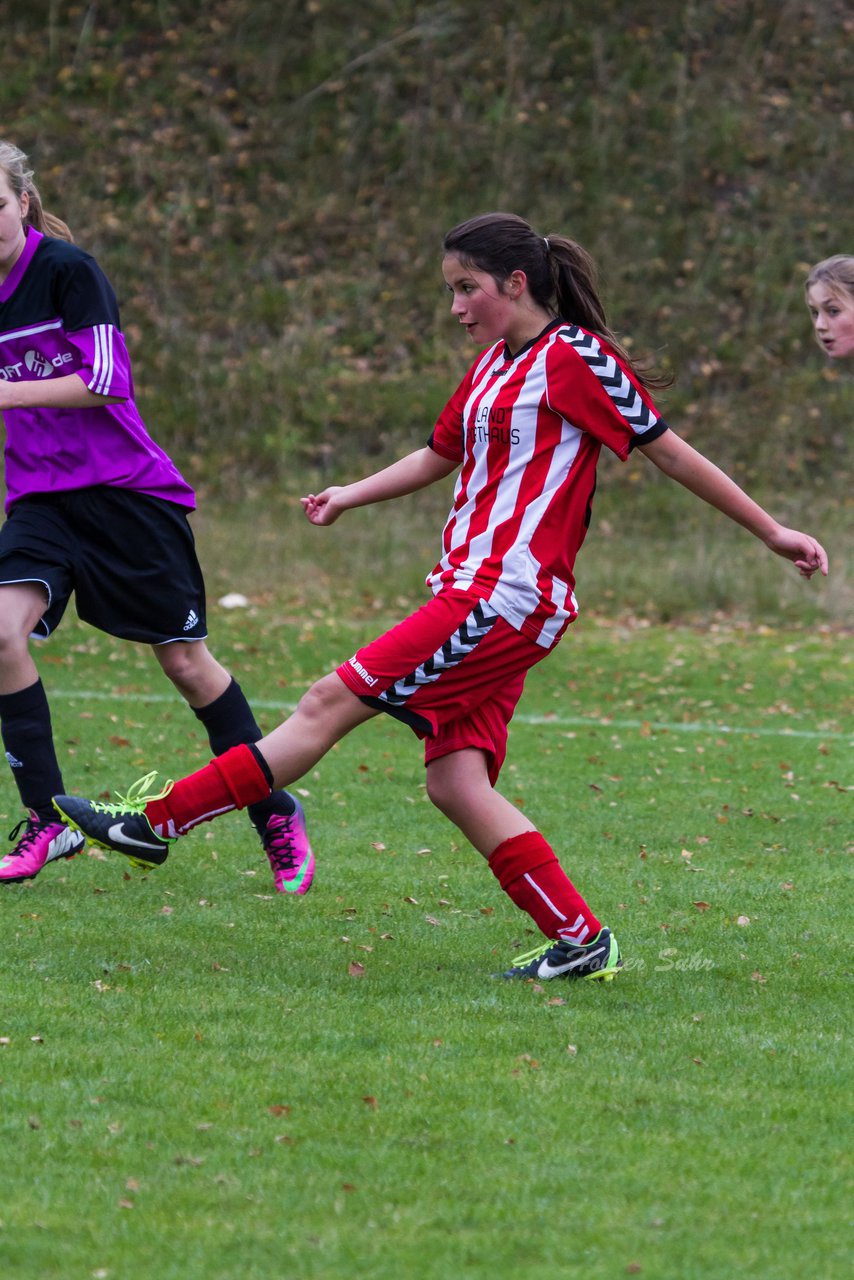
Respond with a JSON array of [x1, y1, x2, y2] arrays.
[[50, 689, 854, 746]]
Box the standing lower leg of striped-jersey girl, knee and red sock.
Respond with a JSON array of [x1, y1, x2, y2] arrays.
[[426, 748, 602, 946]]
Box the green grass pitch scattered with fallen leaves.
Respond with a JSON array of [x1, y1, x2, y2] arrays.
[[0, 603, 851, 1280]]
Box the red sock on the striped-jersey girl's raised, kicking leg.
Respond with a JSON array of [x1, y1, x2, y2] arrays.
[[145, 745, 271, 837]]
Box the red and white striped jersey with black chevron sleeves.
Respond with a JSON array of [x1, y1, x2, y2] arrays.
[[426, 320, 667, 648]]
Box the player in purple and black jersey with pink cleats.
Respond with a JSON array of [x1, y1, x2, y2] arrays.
[[0, 142, 314, 893]]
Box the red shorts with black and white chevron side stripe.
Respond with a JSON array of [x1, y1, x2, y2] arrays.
[[338, 590, 549, 786]]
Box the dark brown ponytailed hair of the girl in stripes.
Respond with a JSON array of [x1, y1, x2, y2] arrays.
[[443, 214, 671, 389]]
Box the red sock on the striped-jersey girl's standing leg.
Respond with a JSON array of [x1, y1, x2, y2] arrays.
[[489, 831, 602, 946]]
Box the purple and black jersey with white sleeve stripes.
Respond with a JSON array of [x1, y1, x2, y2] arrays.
[[0, 227, 196, 511]]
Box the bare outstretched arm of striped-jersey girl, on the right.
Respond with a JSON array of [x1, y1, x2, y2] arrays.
[[639, 430, 827, 577]]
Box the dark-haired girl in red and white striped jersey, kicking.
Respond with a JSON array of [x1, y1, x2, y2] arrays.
[[53, 214, 827, 979]]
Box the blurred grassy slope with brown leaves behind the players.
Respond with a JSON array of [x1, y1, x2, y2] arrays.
[[0, 0, 854, 619]]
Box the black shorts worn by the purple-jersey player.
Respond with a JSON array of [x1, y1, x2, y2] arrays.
[[0, 485, 207, 644]]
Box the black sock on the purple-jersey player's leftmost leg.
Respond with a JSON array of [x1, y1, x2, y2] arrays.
[[0, 680, 65, 822]]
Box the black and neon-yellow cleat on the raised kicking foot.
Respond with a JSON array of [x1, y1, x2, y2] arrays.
[[54, 773, 174, 872]]
